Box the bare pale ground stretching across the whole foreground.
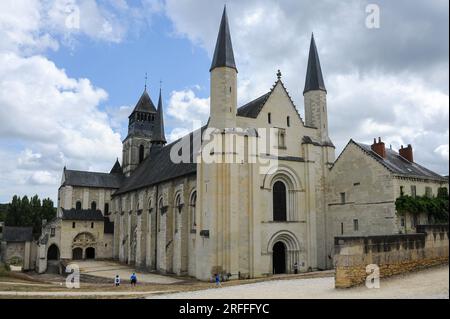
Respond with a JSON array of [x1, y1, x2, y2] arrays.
[[0, 262, 449, 299]]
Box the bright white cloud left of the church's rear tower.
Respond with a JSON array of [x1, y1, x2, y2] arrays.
[[0, 0, 135, 201]]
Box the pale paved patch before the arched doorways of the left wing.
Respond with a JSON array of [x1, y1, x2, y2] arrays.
[[74, 260, 182, 284]]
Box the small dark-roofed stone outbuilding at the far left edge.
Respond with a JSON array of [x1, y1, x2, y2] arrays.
[[0, 226, 36, 270]]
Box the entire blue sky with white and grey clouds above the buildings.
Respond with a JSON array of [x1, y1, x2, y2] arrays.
[[0, 0, 449, 202]]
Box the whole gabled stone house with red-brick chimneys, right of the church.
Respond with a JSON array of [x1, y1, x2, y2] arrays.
[[327, 138, 448, 267]]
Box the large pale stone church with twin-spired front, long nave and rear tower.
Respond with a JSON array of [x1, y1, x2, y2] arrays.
[[112, 5, 334, 279]]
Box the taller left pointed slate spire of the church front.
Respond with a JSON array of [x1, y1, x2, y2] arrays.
[[209, 6, 237, 72]]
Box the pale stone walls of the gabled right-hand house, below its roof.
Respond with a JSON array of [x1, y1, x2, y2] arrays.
[[326, 141, 448, 267]]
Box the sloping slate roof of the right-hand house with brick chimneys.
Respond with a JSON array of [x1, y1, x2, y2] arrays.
[[356, 140, 447, 182]]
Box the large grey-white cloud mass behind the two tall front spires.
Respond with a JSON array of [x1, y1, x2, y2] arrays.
[[166, 0, 449, 174]]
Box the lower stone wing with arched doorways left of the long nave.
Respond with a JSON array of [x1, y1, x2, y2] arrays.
[[36, 160, 123, 273]]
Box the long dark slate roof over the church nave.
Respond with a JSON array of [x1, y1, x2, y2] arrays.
[[113, 126, 206, 196]]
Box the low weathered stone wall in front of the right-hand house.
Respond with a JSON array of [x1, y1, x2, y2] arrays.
[[334, 225, 449, 288]]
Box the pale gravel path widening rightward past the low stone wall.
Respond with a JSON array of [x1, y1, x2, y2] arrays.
[[148, 265, 449, 299]]
